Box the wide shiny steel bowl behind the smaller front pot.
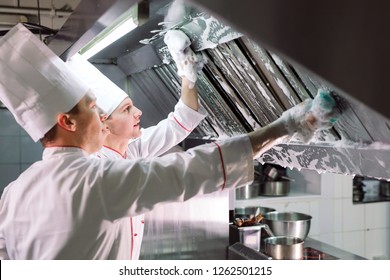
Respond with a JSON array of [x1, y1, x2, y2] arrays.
[[263, 211, 312, 240]]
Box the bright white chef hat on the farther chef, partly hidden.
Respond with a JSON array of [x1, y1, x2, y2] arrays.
[[66, 53, 128, 115]]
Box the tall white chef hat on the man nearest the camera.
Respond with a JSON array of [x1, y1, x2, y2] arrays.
[[0, 23, 88, 142]]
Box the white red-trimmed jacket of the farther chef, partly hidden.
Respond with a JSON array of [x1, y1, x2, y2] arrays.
[[95, 99, 205, 260]]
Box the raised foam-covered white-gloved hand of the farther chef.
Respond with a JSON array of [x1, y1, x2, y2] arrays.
[[164, 30, 206, 88]]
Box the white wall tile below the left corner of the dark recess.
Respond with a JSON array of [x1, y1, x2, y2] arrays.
[[341, 198, 366, 232]]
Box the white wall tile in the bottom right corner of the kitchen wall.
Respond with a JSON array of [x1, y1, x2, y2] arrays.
[[364, 229, 390, 259]]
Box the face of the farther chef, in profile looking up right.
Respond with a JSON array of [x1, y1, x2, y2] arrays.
[[106, 97, 142, 140]]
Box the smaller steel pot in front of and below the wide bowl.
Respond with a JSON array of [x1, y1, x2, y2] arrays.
[[264, 236, 304, 260]]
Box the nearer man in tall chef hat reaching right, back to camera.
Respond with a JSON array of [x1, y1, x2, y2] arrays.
[[0, 24, 337, 259]]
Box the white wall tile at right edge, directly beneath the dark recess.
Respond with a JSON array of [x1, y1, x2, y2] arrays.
[[365, 202, 390, 230]]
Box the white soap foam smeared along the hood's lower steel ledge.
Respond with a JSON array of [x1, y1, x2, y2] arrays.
[[259, 135, 390, 179]]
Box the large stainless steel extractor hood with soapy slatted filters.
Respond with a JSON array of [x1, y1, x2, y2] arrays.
[[40, 0, 390, 179]]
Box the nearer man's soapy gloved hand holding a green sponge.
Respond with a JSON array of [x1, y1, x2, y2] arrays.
[[281, 89, 341, 143]]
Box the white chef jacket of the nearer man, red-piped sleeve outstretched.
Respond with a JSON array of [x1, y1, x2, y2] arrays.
[[0, 135, 253, 259]]
